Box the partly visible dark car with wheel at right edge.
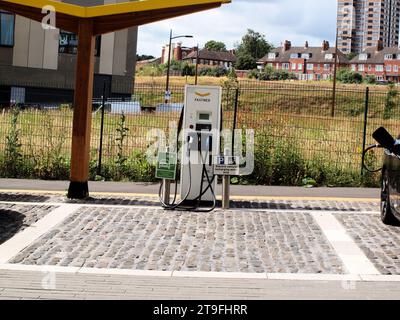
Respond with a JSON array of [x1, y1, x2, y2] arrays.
[[373, 128, 400, 226]]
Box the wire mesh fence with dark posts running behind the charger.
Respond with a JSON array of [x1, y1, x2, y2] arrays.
[[0, 81, 400, 185]]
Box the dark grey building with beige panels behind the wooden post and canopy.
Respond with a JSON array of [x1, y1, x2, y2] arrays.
[[0, 0, 137, 104]]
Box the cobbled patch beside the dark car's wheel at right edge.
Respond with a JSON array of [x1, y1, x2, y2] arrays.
[[336, 214, 400, 275]]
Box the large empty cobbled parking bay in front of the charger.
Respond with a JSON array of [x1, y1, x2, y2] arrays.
[[11, 207, 344, 274]]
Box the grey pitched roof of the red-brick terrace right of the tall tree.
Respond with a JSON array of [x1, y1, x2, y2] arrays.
[[258, 47, 349, 64]]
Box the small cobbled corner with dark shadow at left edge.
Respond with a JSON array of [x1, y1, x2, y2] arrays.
[[0, 204, 57, 244]]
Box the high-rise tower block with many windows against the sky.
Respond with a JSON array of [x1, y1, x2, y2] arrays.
[[337, 0, 400, 54]]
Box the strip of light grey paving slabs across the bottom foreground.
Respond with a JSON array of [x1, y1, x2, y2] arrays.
[[0, 270, 400, 300]]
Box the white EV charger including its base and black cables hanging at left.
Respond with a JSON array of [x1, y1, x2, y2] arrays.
[[157, 85, 222, 211]]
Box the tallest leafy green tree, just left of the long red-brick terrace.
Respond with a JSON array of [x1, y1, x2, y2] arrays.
[[236, 29, 273, 60]]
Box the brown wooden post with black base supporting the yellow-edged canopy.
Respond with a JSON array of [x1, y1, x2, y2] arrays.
[[68, 19, 95, 199]]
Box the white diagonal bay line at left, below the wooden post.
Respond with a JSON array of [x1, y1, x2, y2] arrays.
[[0, 204, 81, 264]]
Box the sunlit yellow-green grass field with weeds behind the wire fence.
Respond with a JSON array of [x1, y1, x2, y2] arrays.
[[0, 79, 400, 186]]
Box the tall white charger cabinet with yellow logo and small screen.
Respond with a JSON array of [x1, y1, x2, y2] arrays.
[[181, 85, 222, 202]]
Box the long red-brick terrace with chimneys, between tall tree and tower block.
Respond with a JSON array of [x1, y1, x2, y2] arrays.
[[258, 40, 349, 80]]
